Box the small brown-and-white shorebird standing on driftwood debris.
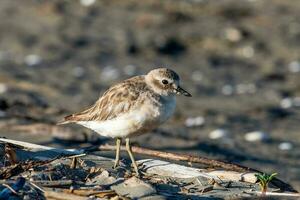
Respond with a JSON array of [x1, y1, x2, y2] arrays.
[[58, 68, 192, 175]]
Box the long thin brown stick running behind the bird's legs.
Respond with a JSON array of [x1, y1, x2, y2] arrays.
[[94, 144, 297, 192]]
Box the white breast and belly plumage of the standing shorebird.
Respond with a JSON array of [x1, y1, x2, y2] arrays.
[[77, 97, 176, 138]]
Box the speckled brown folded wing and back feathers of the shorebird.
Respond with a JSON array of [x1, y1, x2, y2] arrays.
[[59, 76, 147, 124]]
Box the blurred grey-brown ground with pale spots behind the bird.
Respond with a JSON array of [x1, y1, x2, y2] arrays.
[[0, 0, 300, 190]]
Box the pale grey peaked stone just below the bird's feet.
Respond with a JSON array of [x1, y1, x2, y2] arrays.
[[111, 177, 156, 199]]
